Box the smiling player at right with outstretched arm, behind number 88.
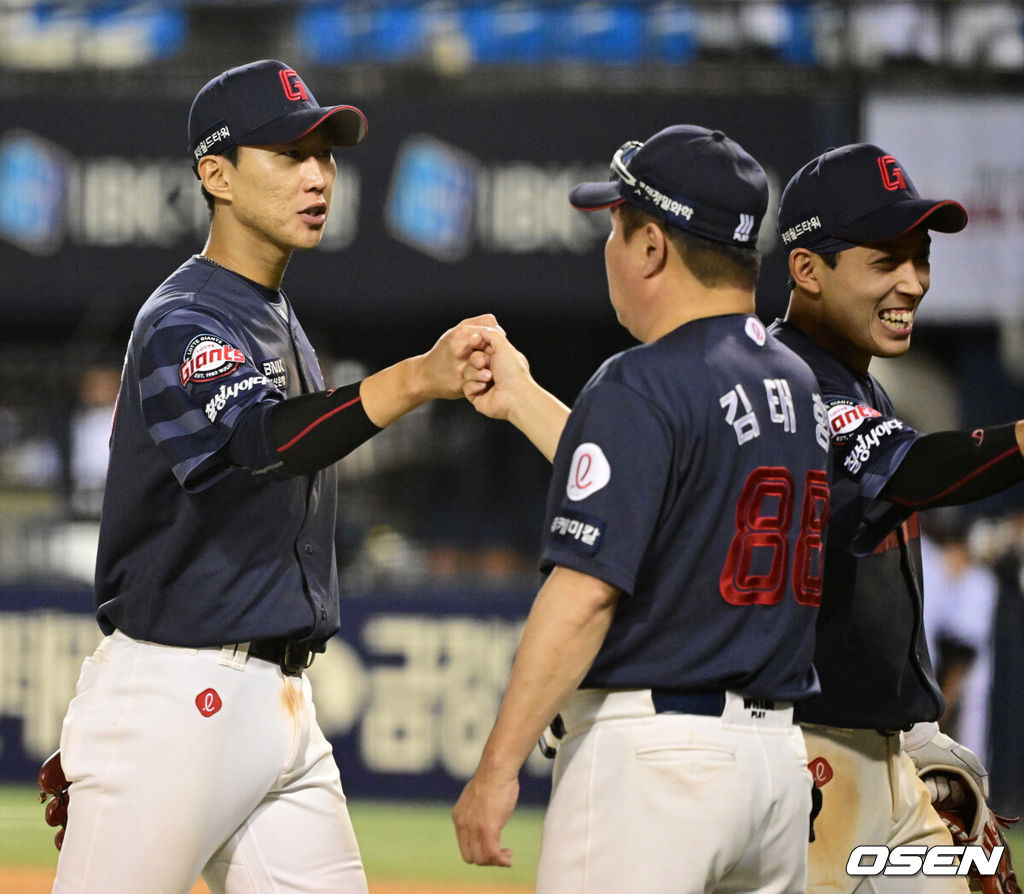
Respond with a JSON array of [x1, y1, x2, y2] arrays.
[[771, 143, 1024, 892]]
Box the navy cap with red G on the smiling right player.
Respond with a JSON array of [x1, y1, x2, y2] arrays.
[[778, 142, 967, 254]]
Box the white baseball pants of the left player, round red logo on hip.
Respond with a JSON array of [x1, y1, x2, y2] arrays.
[[53, 632, 368, 894]]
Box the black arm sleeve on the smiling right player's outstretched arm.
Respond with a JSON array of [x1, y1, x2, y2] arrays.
[[879, 423, 1024, 509]]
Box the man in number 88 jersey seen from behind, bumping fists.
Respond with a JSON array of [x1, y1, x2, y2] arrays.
[[453, 125, 828, 894]]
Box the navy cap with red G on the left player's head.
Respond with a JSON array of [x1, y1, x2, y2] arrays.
[[188, 59, 367, 176]]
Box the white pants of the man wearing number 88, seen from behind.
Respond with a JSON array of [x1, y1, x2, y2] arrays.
[[537, 690, 811, 894]]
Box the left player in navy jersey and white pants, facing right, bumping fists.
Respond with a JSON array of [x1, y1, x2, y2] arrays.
[[44, 60, 496, 894]]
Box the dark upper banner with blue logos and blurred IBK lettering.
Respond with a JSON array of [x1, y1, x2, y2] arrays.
[[0, 93, 852, 338]]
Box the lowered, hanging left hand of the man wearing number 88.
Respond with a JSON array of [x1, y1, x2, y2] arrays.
[[452, 770, 519, 866]]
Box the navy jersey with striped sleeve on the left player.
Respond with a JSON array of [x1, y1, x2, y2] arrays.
[[96, 257, 339, 647]]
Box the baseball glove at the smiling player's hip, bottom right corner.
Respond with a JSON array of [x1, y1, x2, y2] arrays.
[[907, 732, 1022, 894]]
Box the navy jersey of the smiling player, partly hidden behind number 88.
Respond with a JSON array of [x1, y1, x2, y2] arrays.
[[770, 321, 945, 730]]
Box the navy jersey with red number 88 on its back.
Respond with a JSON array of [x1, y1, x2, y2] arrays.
[[542, 314, 828, 700]]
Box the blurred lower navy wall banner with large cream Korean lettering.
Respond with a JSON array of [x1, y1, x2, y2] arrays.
[[0, 585, 551, 804]]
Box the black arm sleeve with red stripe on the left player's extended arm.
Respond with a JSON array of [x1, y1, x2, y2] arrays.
[[227, 382, 381, 477]]
